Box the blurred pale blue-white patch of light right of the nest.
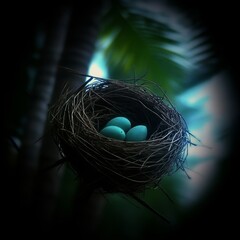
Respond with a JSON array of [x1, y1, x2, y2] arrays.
[[173, 73, 234, 207]]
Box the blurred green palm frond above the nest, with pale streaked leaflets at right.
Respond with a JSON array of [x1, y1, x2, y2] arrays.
[[97, 1, 217, 96]]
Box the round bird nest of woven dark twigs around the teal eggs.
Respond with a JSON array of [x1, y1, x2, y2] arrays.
[[50, 78, 190, 193]]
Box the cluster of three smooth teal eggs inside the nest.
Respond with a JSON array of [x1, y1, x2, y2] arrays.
[[100, 117, 148, 141]]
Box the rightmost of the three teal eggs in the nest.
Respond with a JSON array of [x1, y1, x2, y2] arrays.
[[125, 125, 148, 141]]
